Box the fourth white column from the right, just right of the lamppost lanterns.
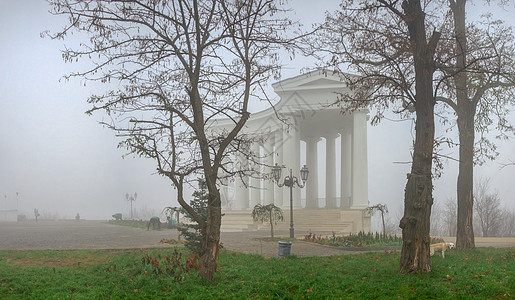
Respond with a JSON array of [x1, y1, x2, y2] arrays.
[[306, 137, 320, 208]]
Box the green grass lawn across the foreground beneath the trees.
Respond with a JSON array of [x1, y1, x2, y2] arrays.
[[0, 247, 515, 299]]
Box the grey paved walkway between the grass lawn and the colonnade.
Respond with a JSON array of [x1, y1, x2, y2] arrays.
[[0, 220, 515, 257]]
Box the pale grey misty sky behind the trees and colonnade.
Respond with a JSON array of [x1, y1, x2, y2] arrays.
[[0, 0, 515, 223]]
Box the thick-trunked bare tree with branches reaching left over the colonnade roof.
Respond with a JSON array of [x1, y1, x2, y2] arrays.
[[313, 0, 441, 273]]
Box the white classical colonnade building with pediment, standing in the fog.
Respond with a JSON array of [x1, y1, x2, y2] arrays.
[[214, 70, 370, 234]]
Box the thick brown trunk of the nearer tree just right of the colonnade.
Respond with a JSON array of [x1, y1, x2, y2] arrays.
[[399, 0, 440, 273]]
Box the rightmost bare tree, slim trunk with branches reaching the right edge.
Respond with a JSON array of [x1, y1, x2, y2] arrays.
[[438, 0, 515, 249]]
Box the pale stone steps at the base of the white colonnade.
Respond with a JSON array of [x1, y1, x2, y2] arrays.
[[221, 209, 355, 235]]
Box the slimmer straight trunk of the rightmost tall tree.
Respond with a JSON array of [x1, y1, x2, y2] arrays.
[[450, 0, 476, 249]]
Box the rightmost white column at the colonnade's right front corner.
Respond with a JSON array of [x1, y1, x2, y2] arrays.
[[351, 111, 368, 209]]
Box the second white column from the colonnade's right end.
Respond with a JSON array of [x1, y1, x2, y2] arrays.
[[340, 128, 352, 208]]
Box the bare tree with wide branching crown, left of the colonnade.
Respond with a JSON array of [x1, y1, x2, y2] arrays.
[[49, 0, 291, 279]]
